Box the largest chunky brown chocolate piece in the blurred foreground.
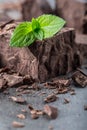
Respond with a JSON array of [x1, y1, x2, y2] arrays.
[[43, 105, 58, 119]]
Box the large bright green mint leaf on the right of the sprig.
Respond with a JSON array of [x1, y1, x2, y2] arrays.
[[37, 15, 65, 39]]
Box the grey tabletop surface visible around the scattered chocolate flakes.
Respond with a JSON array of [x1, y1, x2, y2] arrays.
[[0, 66, 87, 130]]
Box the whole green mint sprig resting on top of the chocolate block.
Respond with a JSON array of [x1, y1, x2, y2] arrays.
[[10, 14, 65, 47]]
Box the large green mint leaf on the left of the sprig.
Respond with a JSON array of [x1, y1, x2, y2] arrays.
[[10, 22, 35, 47]]
